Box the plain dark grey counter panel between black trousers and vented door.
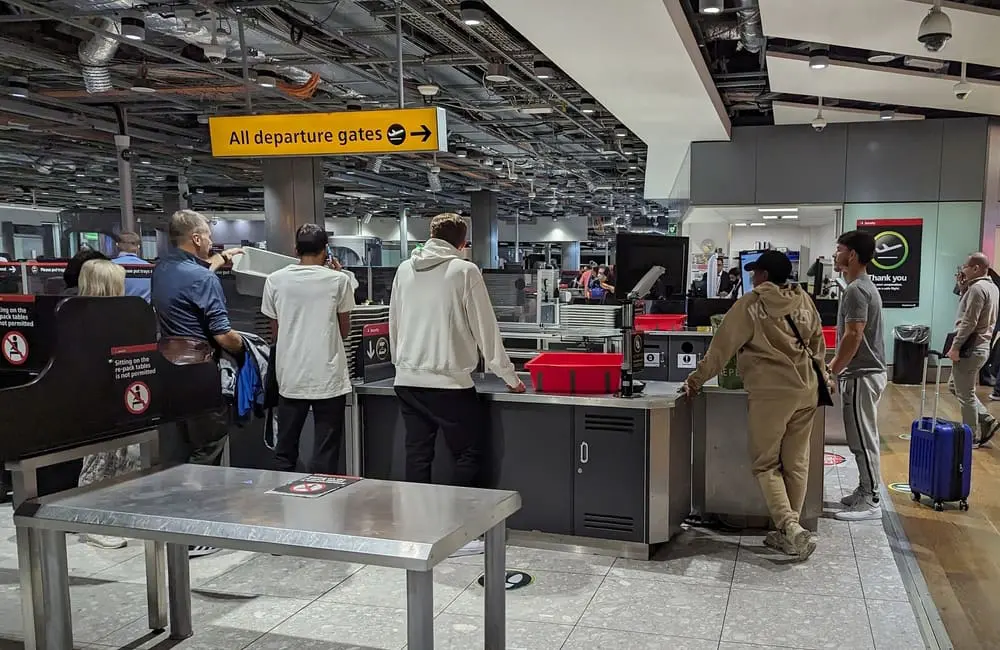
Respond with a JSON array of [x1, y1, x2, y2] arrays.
[[489, 402, 573, 535]]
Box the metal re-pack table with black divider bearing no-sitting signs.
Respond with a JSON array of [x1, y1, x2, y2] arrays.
[[0, 295, 520, 650]]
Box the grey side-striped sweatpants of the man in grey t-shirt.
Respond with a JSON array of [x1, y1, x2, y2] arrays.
[[840, 372, 886, 501]]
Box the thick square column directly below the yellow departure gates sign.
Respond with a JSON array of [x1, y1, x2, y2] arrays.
[[263, 158, 326, 255]]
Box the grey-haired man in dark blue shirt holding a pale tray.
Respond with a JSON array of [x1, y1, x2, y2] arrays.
[[151, 210, 243, 556]]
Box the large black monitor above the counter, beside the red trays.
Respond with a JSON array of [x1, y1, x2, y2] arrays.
[[615, 233, 688, 300]]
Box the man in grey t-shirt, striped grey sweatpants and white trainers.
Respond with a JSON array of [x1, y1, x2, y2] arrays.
[[830, 230, 886, 521]]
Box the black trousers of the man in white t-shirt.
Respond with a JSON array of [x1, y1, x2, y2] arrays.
[[274, 395, 347, 474]]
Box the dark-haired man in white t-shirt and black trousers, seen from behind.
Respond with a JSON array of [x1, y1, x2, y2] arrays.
[[261, 223, 354, 474]]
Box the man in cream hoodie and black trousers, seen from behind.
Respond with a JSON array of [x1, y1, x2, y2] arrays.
[[389, 213, 525, 506]]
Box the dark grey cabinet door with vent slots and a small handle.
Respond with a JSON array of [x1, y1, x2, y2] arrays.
[[573, 408, 648, 542]]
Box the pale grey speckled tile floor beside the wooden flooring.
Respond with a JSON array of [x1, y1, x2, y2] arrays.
[[0, 446, 925, 650]]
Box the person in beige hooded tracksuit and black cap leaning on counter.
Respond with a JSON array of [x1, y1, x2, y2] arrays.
[[684, 251, 829, 560]]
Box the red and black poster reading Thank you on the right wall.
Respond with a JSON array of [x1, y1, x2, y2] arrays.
[[858, 219, 924, 307]]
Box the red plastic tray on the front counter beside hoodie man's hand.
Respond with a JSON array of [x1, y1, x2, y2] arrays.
[[524, 352, 622, 395]]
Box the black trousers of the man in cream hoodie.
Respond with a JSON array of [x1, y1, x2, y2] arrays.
[[396, 386, 486, 487]]
